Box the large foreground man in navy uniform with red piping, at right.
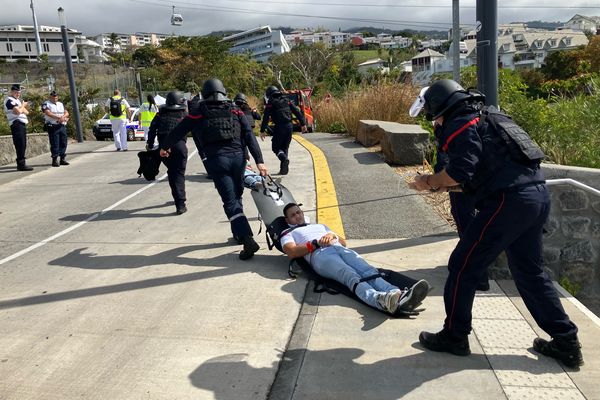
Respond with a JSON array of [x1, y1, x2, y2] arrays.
[[411, 79, 583, 368]]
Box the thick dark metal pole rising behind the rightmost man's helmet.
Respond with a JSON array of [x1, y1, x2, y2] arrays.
[[476, 0, 498, 106]]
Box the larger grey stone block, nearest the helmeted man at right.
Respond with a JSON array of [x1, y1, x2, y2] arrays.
[[381, 122, 429, 165]]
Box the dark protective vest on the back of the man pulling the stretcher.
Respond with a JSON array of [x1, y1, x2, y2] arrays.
[[199, 103, 242, 146]]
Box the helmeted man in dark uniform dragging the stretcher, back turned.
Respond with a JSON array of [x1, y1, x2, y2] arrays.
[[160, 79, 267, 260]]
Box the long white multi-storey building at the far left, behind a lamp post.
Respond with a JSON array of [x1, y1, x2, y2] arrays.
[[0, 25, 85, 62]]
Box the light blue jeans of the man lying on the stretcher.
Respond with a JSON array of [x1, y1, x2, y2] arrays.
[[310, 246, 399, 310]]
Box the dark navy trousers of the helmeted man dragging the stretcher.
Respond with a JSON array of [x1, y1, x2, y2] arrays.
[[205, 151, 252, 238]]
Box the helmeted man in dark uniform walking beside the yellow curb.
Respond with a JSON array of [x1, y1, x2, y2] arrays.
[[260, 86, 307, 175]]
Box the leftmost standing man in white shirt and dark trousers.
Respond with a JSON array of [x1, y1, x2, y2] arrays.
[[3, 83, 33, 171]]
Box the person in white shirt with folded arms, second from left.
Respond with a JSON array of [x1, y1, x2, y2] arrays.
[[42, 90, 69, 167]]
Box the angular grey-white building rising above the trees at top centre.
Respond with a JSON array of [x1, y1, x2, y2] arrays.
[[222, 25, 290, 62]]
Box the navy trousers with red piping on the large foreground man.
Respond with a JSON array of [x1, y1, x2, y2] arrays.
[[444, 184, 577, 338]]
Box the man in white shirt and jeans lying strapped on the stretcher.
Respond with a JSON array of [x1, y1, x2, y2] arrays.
[[281, 203, 429, 314]]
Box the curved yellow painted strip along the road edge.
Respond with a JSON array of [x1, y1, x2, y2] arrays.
[[293, 134, 346, 238]]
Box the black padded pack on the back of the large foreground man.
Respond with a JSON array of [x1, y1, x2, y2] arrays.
[[477, 106, 544, 166]]
